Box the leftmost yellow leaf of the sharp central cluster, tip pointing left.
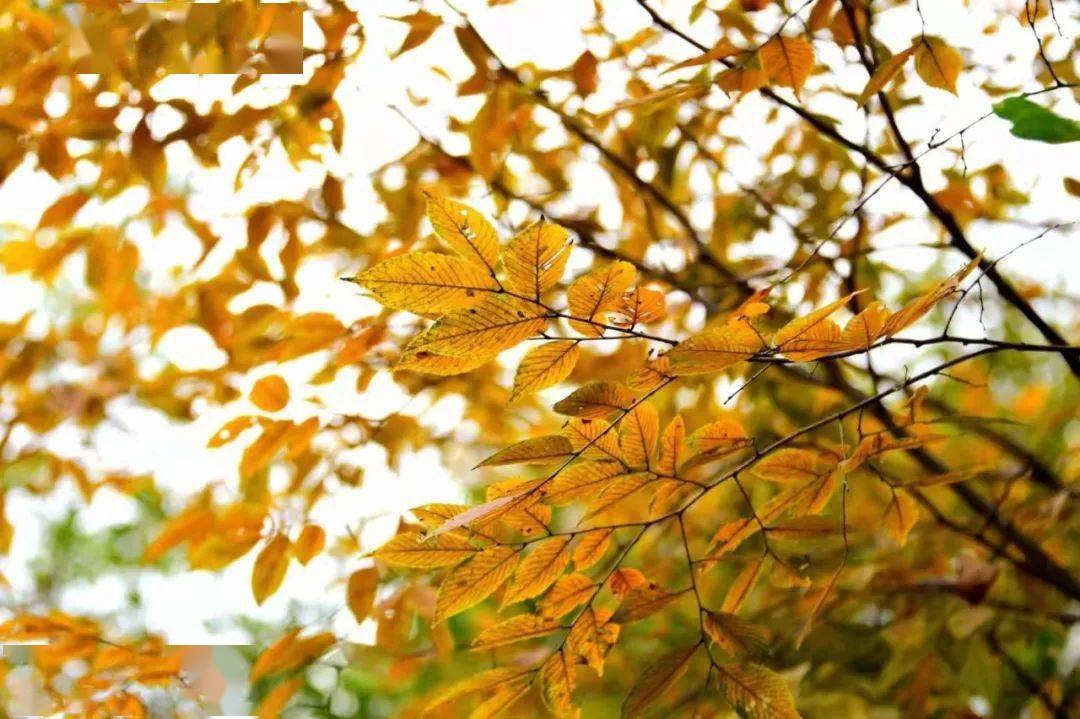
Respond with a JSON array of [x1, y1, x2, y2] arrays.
[[352, 253, 499, 314]]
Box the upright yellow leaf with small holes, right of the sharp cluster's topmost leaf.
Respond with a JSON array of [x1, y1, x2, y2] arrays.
[[502, 219, 570, 299]]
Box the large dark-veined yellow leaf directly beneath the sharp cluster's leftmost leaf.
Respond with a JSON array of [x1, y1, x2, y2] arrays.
[[406, 295, 545, 358]]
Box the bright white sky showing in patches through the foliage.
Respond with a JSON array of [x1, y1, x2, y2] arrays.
[[0, 0, 1080, 643]]
